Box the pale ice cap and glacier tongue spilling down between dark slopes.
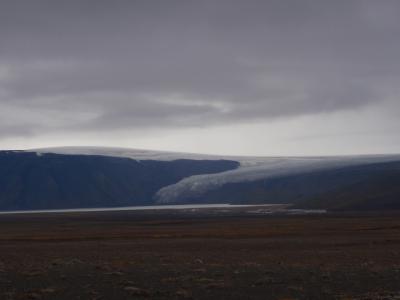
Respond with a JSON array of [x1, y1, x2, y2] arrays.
[[27, 147, 400, 204]]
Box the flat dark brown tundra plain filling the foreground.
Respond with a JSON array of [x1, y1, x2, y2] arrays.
[[0, 210, 400, 300]]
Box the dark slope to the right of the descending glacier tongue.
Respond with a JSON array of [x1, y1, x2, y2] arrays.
[[168, 161, 400, 210]]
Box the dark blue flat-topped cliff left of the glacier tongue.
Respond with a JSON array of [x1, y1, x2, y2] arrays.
[[0, 151, 239, 210]]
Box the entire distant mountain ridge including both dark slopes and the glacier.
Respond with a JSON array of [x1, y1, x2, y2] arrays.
[[0, 148, 400, 210]]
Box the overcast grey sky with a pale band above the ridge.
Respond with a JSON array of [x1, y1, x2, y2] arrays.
[[0, 0, 400, 155]]
